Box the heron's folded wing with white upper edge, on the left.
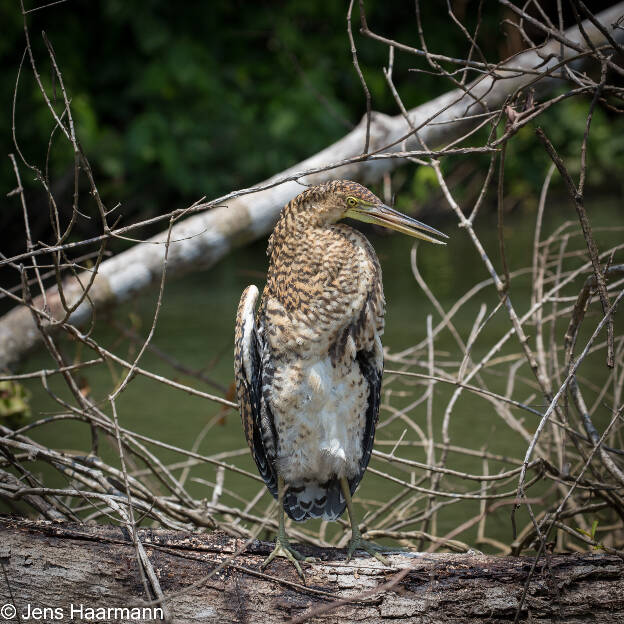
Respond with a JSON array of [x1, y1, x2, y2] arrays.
[[234, 285, 277, 497]]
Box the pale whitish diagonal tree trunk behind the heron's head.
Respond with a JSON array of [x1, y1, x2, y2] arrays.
[[0, 2, 624, 370]]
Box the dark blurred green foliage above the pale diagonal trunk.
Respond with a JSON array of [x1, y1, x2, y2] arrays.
[[0, 0, 624, 256]]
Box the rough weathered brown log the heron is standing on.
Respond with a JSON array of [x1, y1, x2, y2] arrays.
[[0, 517, 624, 624]]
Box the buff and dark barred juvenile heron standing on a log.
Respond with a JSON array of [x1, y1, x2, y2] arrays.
[[234, 180, 447, 578]]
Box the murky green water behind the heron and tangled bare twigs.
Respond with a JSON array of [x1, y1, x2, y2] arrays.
[[9, 202, 624, 542]]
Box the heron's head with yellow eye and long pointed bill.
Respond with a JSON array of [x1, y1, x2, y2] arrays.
[[327, 180, 448, 245]]
